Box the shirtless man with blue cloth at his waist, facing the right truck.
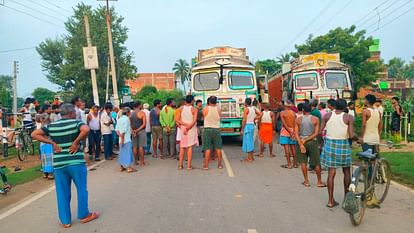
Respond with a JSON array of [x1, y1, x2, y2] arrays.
[[279, 100, 298, 169]]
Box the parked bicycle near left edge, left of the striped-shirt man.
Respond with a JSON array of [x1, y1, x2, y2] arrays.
[[15, 127, 35, 161]]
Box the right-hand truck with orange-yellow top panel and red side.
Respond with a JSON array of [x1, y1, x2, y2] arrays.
[[268, 52, 354, 109]]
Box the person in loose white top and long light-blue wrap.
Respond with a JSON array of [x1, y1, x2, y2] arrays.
[[115, 107, 137, 173]]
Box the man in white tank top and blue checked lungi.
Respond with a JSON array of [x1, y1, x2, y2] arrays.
[[321, 99, 354, 208]]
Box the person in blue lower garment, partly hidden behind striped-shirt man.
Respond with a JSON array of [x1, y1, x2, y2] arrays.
[[36, 113, 54, 180]]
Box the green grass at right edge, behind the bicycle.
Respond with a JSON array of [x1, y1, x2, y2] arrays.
[[352, 148, 414, 186]]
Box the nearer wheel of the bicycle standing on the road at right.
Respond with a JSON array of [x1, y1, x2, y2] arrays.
[[349, 167, 368, 226]]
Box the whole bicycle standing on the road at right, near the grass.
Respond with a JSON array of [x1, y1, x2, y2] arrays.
[[342, 142, 393, 226]]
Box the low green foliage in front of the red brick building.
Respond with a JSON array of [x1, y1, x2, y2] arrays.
[[132, 86, 183, 108]]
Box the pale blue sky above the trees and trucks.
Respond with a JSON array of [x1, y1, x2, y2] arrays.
[[0, 0, 414, 97]]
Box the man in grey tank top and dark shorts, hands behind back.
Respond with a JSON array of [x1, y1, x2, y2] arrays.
[[295, 104, 326, 187]]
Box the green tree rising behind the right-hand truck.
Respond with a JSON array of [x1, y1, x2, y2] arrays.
[[295, 26, 384, 90]]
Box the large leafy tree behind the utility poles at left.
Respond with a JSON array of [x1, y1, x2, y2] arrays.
[[36, 3, 137, 103]]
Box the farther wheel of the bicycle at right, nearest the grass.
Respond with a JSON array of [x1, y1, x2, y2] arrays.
[[374, 159, 391, 204]]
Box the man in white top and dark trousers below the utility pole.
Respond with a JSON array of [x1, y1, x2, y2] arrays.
[[86, 106, 102, 161]]
